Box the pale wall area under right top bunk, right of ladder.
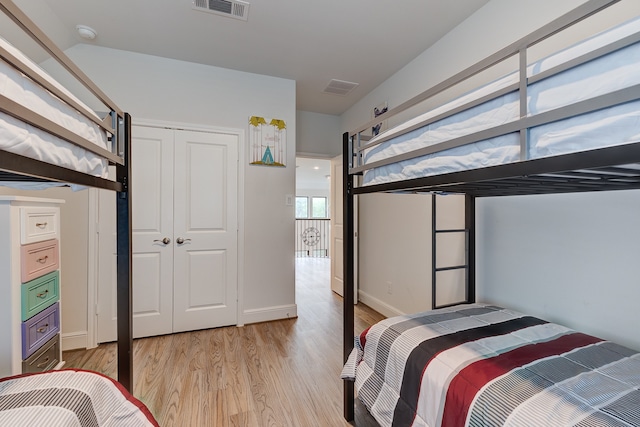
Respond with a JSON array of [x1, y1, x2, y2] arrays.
[[476, 190, 640, 348]]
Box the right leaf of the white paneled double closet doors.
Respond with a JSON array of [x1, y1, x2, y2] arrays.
[[173, 131, 239, 332]]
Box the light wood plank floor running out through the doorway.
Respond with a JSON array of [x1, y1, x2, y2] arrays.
[[64, 258, 383, 427]]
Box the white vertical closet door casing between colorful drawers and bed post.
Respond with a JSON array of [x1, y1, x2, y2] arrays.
[[86, 188, 99, 348]]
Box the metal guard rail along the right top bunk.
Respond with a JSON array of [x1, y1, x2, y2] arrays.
[[346, 0, 624, 179]]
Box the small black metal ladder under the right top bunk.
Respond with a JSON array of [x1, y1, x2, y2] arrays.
[[431, 193, 475, 309]]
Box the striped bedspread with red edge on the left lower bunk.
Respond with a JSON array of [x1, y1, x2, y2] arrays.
[[0, 369, 158, 427]]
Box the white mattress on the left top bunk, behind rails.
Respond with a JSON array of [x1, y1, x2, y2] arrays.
[[0, 38, 108, 177]]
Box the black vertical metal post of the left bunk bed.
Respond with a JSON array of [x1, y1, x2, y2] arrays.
[[116, 114, 133, 393]]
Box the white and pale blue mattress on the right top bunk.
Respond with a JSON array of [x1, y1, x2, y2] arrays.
[[363, 18, 640, 185]]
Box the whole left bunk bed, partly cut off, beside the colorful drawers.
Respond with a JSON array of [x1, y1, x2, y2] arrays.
[[0, 0, 157, 425]]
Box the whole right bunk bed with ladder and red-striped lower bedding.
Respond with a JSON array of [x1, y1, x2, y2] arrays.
[[342, 0, 640, 427]]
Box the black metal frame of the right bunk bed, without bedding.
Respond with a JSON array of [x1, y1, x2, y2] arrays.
[[343, 0, 640, 421]]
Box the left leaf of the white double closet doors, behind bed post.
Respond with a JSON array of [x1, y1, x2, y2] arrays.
[[97, 126, 174, 343]]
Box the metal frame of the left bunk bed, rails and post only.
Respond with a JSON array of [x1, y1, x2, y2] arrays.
[[0, 0, 133, 392]]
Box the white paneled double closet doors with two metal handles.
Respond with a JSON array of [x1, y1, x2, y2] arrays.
[[98, 126, 239, 342]]
